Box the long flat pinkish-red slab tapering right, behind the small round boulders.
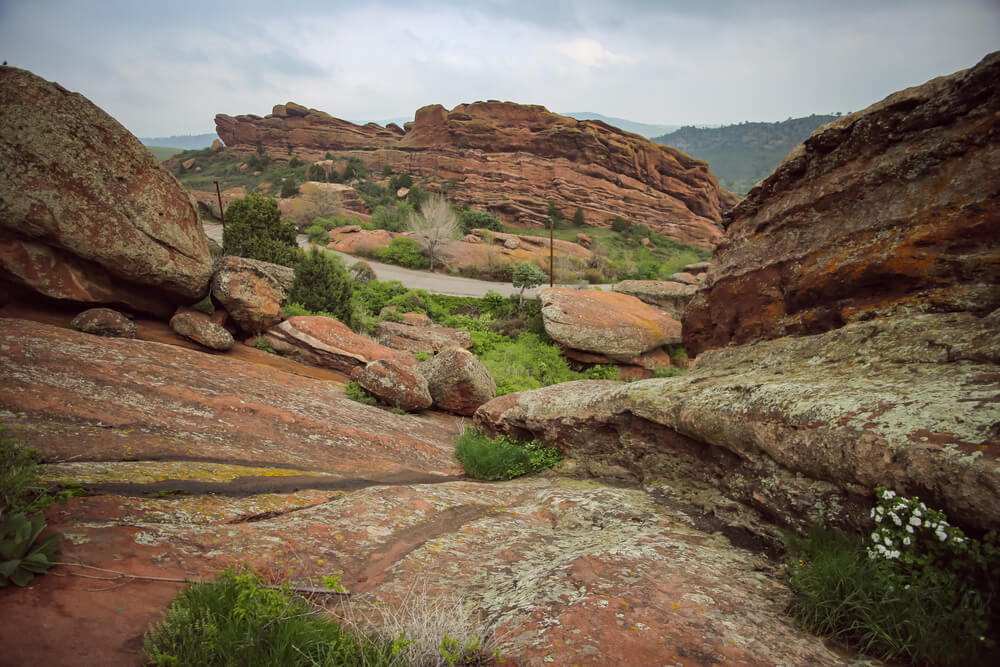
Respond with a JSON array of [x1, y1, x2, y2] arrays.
[[263, 315, 417, 373]]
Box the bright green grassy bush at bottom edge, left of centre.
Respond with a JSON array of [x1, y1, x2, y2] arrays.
[[143, 570, 402, 667]]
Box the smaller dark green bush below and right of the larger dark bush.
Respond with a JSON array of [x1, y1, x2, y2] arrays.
[[288, 248, 354, 326]]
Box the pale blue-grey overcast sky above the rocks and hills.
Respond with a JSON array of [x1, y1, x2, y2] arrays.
[[0, 0, 1000, 136]]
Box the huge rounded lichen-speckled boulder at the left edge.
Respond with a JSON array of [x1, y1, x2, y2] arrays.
[[0, 67, 212, 319]]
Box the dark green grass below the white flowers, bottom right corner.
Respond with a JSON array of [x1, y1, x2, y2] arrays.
[[786, 528, 995, 665]]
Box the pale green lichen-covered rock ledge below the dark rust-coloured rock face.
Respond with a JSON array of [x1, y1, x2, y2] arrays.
[[475, 311, 1000, 532]]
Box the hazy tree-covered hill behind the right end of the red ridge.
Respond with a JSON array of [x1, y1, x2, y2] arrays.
[[653, 114, 837, 195]]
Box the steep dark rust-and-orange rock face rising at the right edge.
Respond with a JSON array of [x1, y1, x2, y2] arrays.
[[684, 52, 1000, 354]]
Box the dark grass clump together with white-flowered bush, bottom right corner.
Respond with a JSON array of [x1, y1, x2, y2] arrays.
[[786, 489, 1000, 665]]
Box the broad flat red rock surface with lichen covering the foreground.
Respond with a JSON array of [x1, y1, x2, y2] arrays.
[[0, 319, 844, 666]]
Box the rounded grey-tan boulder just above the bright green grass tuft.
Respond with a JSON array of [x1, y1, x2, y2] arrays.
[[417, 347, 497, 415]]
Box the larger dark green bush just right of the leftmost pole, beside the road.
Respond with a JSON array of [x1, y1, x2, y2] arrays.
[[222, 193, 299, 267]]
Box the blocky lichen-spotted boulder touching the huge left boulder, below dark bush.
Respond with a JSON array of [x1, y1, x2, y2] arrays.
[[212, 256, 295, 334]]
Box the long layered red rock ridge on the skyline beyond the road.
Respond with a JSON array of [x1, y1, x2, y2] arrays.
[[216, 102, 736, 248]]
